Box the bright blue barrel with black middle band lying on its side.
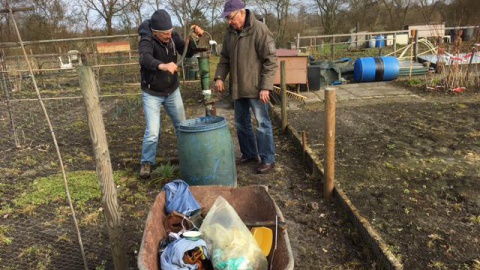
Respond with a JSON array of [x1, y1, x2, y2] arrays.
[[353, 56, 400, 82]]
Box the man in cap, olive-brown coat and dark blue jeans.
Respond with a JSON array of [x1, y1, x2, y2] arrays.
[[215, 0, 277, 173]]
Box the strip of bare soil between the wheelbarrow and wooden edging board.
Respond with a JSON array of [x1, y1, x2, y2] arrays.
[[213, 102, 376, 269]]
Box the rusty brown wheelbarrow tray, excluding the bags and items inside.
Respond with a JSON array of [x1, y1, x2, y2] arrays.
[[138, 186, 294, 270]]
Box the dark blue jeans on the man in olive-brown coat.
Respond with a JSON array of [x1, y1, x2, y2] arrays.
[[234, 98, 275, 163]]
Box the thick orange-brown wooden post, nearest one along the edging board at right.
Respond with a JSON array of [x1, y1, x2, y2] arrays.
[[323, 87, 335, 200]]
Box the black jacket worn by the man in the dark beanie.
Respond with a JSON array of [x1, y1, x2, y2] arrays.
[[138, 20, 194, 96]]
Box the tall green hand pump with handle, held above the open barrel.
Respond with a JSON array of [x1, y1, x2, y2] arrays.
[[177, 25, 217, 116]]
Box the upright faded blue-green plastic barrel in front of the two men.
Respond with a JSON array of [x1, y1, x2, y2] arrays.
[[178, 116, 237, 187]]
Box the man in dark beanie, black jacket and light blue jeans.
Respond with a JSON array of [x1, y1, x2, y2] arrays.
[[138, 9, 203, 178]]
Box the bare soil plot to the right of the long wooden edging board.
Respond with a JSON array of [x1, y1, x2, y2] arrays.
[[288, 83, 480, 269]]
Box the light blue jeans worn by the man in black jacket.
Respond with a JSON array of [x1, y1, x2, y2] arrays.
[[141, 88, 185, 165]]
